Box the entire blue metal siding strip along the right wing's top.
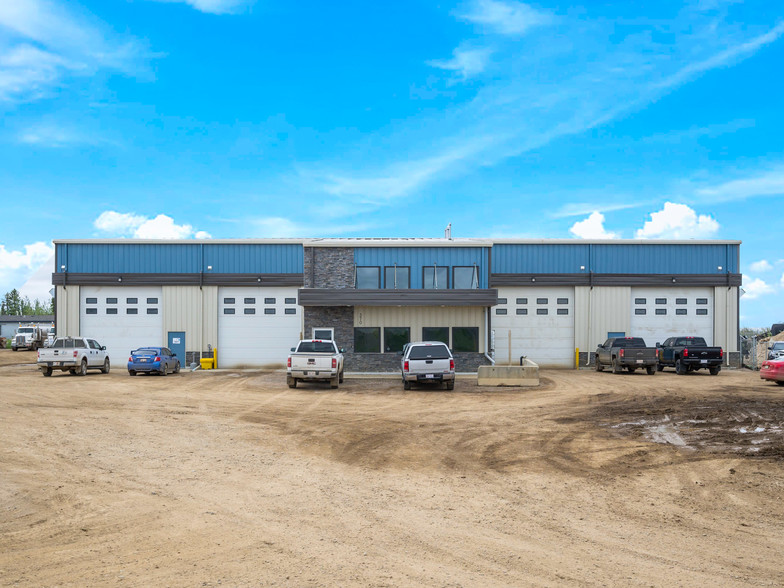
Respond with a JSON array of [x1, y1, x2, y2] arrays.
[[492, 243, 739, 274]]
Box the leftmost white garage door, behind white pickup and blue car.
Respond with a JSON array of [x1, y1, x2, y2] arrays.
[[79, 286, 163, 367]]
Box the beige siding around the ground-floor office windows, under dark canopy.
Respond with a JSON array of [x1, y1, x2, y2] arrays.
[[354, 306, 486, 351]]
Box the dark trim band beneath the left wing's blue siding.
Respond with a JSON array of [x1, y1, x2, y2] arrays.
[[52, 272, 302, 287]]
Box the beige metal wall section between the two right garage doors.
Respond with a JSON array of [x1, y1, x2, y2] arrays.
[[575, 286, 632, 352]]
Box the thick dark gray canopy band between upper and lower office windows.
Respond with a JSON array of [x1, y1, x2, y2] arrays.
[[299, 288, 498, 306]]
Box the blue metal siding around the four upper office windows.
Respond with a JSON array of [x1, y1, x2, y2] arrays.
[[354, 247, 488, 289]]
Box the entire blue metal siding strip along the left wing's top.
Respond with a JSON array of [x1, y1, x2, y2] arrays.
[[57, 243, 303, 274]]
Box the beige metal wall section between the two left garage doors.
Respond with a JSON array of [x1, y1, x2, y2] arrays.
[[163, 286, 218, 351]]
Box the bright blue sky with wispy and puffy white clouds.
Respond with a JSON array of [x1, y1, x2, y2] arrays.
[[0, 0, 784, 327]]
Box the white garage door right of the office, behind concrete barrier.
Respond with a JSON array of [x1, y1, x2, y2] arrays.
[[491, 286, 574, 367]]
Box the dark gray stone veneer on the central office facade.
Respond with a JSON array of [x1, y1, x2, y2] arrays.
[[303, 247, 490, 373]]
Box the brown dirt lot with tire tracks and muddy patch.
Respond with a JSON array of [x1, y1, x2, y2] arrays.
[[0, 351, 784, 587]]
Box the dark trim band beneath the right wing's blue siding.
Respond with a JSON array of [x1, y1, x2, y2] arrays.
[[490, 274, 742, 288]]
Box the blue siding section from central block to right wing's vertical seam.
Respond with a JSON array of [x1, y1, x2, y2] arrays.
[[493, 243, 590, 274]]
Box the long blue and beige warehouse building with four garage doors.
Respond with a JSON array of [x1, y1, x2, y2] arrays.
[[52, 239, 741, 372]]
